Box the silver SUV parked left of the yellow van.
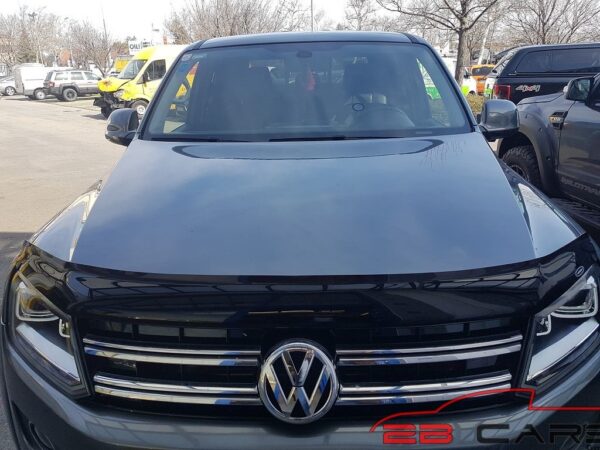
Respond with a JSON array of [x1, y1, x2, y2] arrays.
[[44, 70, 100, 102]]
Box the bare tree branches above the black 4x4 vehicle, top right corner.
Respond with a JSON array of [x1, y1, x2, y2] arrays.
[[506, 0, 600, 44]]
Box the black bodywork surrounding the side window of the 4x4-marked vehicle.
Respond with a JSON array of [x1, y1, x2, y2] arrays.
[[488, 44, 600, 104]]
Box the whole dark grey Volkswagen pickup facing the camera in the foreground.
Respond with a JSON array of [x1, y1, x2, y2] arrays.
[[0, 32, 600, 450]]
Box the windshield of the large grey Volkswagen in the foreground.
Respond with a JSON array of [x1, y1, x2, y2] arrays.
[[144, 42, 469, 141]]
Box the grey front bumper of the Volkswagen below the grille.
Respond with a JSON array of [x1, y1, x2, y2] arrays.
[[2, 330, 600, 450]]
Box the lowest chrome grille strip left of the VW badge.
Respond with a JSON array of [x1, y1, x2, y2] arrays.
[[94, 386, 261, 406]]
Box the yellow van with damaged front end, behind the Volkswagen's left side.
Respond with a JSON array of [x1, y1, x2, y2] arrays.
[[94, 45, 185, 117]]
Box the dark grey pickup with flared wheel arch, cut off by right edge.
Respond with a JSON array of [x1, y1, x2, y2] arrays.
[[497, 75, 600, 229]]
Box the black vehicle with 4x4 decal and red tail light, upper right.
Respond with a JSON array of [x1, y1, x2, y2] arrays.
[[485, 43, 600, 103]]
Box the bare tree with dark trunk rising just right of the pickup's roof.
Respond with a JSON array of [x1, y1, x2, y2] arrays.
[[377, 0, 499, 84]]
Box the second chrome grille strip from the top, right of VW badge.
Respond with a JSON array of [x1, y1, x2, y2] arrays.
[[338, 343, 521, 366]]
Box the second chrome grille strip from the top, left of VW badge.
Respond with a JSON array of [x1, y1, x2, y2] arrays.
[[84, 346, 258, 367]]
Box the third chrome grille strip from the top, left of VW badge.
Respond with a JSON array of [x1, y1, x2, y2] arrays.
[[94, 374, 258, 396]]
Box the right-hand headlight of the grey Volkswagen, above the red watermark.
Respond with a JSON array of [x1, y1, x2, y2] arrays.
[[526, 266, 600, 386]]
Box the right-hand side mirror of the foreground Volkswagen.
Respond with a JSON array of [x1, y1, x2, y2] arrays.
[[479, 100, 519, 141]]
